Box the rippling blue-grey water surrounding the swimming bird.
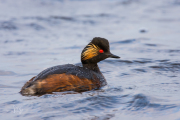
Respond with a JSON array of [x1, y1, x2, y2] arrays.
[[0, 0, 180, 120]]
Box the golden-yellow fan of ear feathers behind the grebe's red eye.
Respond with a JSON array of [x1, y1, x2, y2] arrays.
[[81, 43, 100, 60]]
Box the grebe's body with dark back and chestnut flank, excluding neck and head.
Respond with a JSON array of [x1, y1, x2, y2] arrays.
[[21, 64, 106, 94]]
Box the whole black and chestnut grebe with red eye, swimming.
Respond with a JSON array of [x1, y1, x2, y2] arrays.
[[20, 37, 120, 95]]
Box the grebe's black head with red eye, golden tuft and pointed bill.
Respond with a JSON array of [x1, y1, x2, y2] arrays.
[[81, 37, 120, 64]]
